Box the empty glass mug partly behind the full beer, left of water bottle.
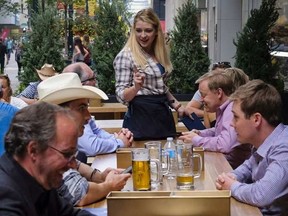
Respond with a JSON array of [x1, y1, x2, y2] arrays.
[[144, 141, 163, 188]]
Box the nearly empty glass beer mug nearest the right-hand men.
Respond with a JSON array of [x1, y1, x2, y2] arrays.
[[176, 142, 202, 190]]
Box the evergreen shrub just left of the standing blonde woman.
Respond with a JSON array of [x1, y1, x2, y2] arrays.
[[92, 0, 127, 94]]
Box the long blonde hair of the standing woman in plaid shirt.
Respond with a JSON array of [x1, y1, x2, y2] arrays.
[[125, 8, 173, 73]]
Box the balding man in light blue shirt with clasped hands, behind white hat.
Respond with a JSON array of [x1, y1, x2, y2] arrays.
[[63, 62, 133, 156]]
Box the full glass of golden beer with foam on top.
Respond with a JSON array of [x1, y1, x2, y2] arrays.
[[132, 148, 151, 191]]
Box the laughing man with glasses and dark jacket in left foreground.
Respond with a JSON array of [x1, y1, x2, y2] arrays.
[[0, 102, 92, 216]]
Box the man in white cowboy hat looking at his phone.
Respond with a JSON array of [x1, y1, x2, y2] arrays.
[[38, 73, 131, 206]]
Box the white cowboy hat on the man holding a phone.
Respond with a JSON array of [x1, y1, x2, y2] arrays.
[[37, 73, 108, 104]]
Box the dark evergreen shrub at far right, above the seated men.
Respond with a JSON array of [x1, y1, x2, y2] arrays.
[[234, 0, 284, 91]]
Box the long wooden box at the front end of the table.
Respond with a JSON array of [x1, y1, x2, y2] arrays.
[[107, 190, 231, 216]]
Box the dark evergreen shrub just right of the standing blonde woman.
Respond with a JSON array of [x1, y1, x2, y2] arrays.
[[169, 0, 210, 94]]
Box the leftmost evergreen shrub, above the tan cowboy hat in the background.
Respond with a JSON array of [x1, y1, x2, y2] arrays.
[[21, 8, 64, 85]]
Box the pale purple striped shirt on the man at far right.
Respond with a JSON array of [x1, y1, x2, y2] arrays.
[[231, 124, 288, 215]]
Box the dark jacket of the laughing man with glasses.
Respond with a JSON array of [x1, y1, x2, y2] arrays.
[[0, 153, 92, 216]]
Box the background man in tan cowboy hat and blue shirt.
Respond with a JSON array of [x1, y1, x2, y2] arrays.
[[18, 63, 58, 104]]
